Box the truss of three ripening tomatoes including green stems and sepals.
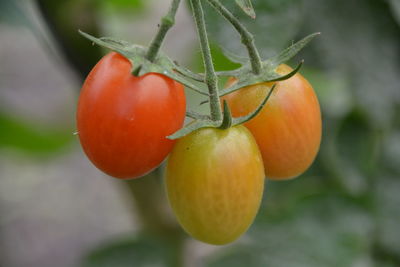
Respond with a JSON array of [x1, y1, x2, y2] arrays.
[[77, 0, 321, 249]]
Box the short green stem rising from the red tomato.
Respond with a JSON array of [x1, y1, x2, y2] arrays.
[[146, 0, 181, 62]]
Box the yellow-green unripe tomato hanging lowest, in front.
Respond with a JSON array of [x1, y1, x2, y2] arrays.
[[166, 126, 265, 245]]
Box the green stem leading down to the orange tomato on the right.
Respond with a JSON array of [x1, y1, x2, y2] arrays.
[[207, 0, 261, 74]]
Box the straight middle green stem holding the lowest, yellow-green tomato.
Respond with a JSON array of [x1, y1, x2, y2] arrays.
[[190, 0, 222, 121]]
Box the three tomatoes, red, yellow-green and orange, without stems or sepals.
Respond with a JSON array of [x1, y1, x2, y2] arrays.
[[77, 52, 321, 244]]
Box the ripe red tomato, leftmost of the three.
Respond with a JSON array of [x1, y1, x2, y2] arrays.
[[77, 52, 186, 179]]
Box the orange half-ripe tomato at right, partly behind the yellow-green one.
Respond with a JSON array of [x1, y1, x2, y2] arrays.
[[222, 65, 321, 179]]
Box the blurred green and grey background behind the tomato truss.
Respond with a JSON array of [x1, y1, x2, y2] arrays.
[[0, 0, 400, 267]]
